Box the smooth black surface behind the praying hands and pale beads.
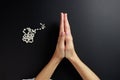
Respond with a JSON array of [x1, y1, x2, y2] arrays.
[[0, 0, 120, 80]]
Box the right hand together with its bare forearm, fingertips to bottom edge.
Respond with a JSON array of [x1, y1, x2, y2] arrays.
[[64, 14, 100, 80]]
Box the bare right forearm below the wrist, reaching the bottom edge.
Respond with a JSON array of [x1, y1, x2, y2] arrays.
[[69, 52, 100, 80]]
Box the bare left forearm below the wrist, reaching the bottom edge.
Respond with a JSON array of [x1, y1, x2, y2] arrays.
[[35, 53, 61, 80]]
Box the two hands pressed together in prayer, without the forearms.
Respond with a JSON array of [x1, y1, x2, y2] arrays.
[[53, 13, 77, 60]]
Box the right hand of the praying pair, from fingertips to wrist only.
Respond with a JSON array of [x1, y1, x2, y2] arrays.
[[64, 13, 77, 59]]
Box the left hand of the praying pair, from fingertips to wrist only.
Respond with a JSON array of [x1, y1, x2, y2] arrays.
[[54, 13, 65, 59]]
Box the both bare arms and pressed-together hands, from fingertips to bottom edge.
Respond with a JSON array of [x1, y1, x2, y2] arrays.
[[35, 13, 100, 80]]
